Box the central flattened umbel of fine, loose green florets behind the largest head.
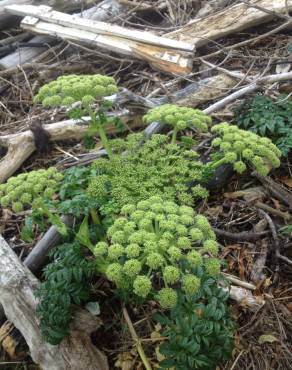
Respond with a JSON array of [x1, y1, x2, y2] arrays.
[[88, 134, 208, 214]]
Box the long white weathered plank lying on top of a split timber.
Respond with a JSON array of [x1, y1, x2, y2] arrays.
[[5, 5, 194, 52]]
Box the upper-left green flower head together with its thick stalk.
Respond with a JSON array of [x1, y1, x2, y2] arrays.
[[34, 74, 118, 158]]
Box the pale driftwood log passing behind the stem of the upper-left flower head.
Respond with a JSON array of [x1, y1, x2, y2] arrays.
[[0, 110, 128, 183]]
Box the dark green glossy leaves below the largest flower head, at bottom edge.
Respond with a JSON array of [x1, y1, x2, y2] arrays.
[[156, 275, 234, 370]]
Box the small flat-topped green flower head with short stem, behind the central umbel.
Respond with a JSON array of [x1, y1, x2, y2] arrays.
[[143, 104, 212, 144]]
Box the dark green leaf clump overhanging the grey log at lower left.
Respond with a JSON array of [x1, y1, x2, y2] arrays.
[[35, 243, 94, 345]]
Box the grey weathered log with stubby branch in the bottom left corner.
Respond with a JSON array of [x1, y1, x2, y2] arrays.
[[0, 236, 108, 370]]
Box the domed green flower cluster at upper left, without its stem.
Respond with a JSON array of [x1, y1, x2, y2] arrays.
[[34, 74, 118, 107]]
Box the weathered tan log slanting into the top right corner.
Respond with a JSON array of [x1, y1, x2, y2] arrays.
[[168, 0, 292, 47]]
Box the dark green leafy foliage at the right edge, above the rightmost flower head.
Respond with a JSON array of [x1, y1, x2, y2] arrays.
[[236, 95, 292, 156]]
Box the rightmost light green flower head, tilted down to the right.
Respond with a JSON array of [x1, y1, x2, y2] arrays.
[[210, 122, 281, 176]]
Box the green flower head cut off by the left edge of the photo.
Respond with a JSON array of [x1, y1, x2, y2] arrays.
[[0, 167, 63, 213]]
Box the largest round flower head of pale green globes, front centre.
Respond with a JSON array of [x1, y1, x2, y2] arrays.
[[92, 196, 220, 308]]
